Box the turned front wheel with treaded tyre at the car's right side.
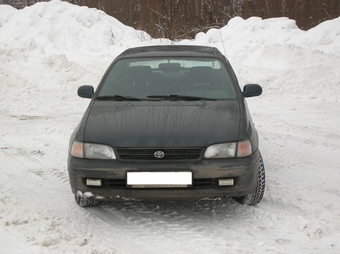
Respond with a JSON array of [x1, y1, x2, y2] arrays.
[[234, 153, 266, 206]]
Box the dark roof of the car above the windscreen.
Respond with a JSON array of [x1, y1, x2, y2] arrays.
[[116, 45, 225, 60]]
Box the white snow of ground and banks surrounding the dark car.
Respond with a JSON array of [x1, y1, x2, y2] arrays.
[[0, 1, 340, 254]]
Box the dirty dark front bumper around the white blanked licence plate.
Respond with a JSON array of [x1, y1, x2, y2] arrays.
[[68, 151, 259, 200]]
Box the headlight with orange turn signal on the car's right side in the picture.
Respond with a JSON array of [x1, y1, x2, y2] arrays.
[[204, 140, 252, 159]]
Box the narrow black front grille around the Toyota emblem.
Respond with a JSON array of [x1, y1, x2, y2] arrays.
[[117, 148, 203, 160]]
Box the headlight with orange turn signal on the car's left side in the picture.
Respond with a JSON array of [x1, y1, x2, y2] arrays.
[[71, 140, 116, 160]]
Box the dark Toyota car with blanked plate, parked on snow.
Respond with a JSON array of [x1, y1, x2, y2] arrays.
[[68, 46, 264, 206]]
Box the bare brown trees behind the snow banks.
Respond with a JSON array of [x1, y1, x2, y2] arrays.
[[5, 0, 340, 40]]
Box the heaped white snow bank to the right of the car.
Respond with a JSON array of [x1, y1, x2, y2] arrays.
[[180, 17, 340, 102]]
